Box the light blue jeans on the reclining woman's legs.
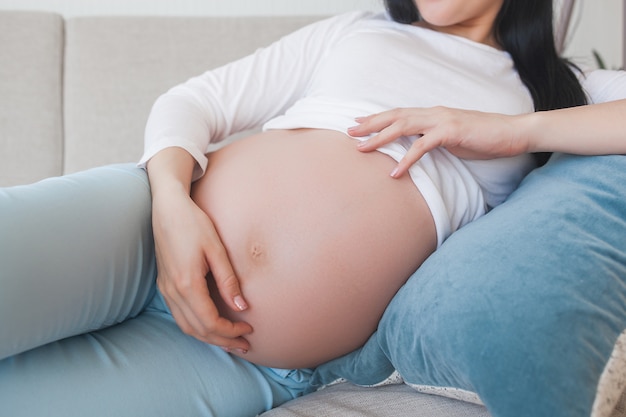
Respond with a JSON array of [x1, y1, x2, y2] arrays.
[[0, 165, 311, 417]]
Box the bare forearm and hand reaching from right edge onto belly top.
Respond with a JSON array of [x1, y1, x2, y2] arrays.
[[348, 100, 626, 178]]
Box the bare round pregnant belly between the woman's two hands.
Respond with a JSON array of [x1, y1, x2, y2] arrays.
[[192, 130, 436, 368]]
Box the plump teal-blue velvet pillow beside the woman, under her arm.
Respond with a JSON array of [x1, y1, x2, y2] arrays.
[[313, 155, 626, 417]]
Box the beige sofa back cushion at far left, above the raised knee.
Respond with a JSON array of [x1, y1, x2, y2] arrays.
[[0, 11, 63, 186]]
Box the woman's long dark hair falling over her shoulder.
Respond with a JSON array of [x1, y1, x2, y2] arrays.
[[385, 0, 587, 163]]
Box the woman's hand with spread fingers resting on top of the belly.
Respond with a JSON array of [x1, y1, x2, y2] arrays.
[[348, 107, 528, 178]]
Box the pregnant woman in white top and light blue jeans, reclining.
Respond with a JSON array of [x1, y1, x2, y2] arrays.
[[0, 0, 623, 417]]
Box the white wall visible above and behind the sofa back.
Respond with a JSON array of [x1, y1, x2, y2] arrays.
[[0, 0, 626, 68]]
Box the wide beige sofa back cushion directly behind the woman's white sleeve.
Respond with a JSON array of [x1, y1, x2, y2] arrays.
[[65, 17, 319, 173]]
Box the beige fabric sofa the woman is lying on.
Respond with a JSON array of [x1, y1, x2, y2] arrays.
[[0, 11, 626, 417]]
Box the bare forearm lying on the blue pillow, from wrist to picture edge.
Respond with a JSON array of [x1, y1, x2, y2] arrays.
[[514, 100, 626, 155]]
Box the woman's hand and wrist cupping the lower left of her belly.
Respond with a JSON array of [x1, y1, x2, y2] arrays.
[[148, 148, 252, 352]]
